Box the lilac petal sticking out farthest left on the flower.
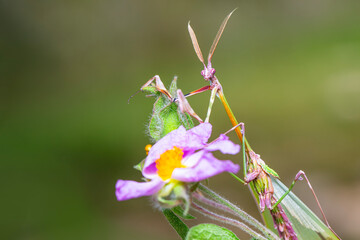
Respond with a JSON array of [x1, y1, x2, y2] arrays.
[[115, 178, 165, 201]]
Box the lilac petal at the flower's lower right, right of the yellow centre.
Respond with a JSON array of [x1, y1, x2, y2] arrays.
[[171, 153, 240, 182]]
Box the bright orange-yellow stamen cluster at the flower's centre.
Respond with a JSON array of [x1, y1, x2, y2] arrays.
[[155, 147, 185, 181]]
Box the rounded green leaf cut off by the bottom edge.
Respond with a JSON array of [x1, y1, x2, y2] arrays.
[[186, 223, 239, 240]]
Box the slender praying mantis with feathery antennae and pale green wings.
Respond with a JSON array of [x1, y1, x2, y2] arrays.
[[184, 9, 340, 239]]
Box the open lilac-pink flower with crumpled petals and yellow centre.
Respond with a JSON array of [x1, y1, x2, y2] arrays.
[[115, 123, 240, 201]]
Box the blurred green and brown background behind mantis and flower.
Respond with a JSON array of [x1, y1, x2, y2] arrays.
[[0, 0, 360, 240]]
